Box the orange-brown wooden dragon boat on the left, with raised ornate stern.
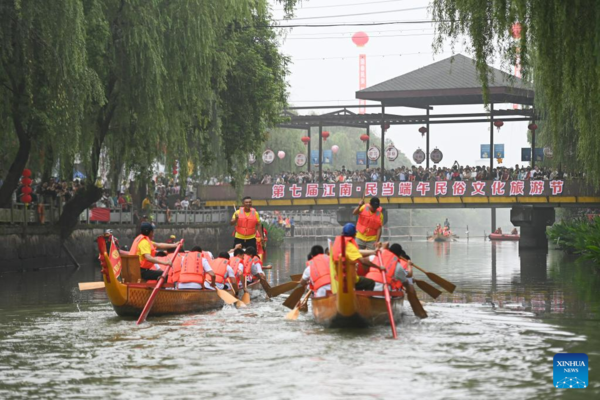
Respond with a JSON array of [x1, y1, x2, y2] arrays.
[[98, 237, 260, 318]]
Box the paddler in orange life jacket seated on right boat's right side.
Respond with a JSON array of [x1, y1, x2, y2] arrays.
[[367, 243, 414, 292]]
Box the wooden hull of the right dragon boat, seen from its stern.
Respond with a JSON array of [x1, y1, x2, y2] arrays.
[[311, 263, 404, 328]]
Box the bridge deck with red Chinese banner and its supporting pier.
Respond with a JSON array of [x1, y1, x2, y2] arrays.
[[198, 180, 600, 248]]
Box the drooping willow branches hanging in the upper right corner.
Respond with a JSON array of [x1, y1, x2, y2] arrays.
[[432, 0, 600, 185]]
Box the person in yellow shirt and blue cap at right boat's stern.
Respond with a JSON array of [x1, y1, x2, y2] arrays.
[[329, 223, 383, 293]]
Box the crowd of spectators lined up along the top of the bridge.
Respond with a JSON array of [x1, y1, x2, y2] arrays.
[[203, 162, 582, 185]]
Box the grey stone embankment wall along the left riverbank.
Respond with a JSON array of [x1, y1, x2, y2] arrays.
[[0, 223, 233, 271]]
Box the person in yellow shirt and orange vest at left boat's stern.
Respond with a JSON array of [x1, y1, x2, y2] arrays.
[[129, 222, 177, 280]]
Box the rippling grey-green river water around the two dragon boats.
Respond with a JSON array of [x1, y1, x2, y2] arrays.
[[0, 239, 600, 400]]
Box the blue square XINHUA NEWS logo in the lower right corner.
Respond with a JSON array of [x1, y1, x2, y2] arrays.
[[553, 353, 588, 389]]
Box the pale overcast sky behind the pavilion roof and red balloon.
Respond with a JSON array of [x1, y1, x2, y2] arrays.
[[271, 0, 529, 166]]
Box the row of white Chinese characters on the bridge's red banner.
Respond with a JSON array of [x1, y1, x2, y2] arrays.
[[271, 180, 564, 199]]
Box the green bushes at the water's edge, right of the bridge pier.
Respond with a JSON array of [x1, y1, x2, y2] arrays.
[[548, 217, 600, 267]]
